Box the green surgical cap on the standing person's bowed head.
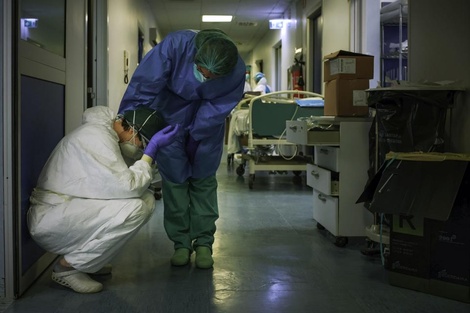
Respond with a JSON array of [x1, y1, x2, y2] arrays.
[[194, 30, 238, 75]]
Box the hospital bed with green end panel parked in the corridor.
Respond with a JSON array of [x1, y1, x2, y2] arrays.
[[227, 90, 323, 189]]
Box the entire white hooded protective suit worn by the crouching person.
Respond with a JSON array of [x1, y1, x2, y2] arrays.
[[28, 106, 155, 273]]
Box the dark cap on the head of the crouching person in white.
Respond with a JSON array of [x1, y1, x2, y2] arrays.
[[124, 107, 166, 141]]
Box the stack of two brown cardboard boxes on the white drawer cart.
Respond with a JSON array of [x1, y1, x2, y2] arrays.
[[323, 50, 374, 116]]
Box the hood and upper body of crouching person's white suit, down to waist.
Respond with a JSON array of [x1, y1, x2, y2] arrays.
[[37, 106, 152, 199]]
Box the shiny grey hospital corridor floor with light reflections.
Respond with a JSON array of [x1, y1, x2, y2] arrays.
[[1, 155, 470, 313]]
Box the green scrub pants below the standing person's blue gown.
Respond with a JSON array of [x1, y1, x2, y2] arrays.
[[162, 175, 219, 251]]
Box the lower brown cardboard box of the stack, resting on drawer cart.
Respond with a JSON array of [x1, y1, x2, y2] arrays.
[[324, 79, 369, 116]]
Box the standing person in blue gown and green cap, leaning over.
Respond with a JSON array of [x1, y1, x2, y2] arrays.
[[119, 29, 246, 268]]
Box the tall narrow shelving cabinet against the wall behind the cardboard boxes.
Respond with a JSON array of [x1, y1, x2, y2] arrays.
[[380, 0, 408, 87]]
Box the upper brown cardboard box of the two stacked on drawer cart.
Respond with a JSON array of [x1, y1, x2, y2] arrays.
[[323, 50, 374, 82]]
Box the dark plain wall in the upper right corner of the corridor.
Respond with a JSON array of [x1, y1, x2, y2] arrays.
[[409, 0, 470, 153]]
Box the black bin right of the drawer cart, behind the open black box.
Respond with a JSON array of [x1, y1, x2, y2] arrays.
[[367, 88, 453, 172]]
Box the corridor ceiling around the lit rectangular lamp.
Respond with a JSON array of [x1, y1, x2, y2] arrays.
[[146, 0, 294, 54]]
